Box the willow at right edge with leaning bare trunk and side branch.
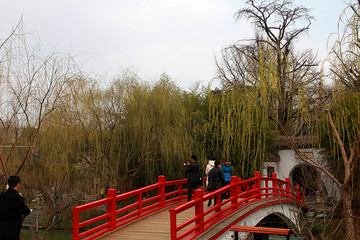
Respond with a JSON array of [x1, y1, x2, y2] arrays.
[[274, 3, 360, 239]]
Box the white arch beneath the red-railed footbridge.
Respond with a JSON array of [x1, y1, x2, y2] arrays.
[[216, 203, 303, 240]]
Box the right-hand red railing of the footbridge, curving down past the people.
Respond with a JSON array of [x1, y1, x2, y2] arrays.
[[169, 172, 304, 240]]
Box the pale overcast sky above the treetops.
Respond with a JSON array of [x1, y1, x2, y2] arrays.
[[0, 0, 346, 90]]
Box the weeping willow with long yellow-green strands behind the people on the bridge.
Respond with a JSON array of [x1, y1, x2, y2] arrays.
[[209, 39, 281, 178]]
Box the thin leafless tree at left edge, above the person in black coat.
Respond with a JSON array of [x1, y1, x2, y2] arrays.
[[0, 21, 79, 186]]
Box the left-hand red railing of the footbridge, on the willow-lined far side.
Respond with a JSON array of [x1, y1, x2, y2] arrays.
[[73, 176, 187, 240]]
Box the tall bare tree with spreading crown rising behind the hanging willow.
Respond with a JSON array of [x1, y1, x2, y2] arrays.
[[216, 0, 319, 133]]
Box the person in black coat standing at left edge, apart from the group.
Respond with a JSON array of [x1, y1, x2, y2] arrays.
[[0, 176, 30, 240]]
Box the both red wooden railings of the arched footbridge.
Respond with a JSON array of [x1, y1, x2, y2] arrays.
[[73, 172, 304, 240]]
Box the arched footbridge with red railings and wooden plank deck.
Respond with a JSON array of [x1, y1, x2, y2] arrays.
[[73, 172, 304, 240]]
